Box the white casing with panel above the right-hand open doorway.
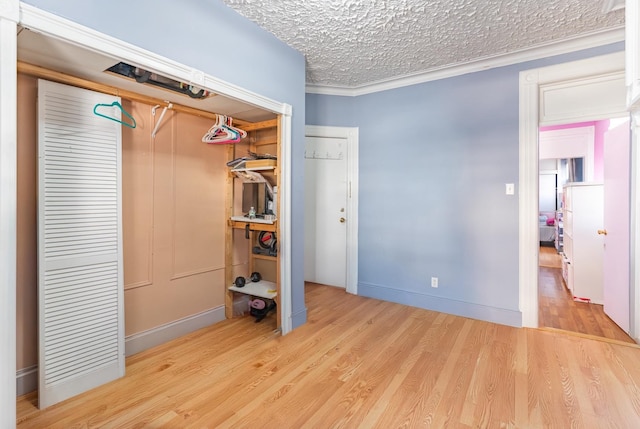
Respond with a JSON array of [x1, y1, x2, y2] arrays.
[[519, 52, 634, 344]]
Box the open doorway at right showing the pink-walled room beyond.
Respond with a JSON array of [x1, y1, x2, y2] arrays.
[[538, 117, 634, 342]]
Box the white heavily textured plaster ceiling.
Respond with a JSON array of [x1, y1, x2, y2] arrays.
[[223, 0, 624, 88]]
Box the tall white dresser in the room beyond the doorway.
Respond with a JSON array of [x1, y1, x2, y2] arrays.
[[562, 183, 604, 304]]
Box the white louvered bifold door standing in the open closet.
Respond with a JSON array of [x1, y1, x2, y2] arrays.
[[38, 80, 124, 408]]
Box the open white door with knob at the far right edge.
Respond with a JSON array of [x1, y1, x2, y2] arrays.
[[603, 117, 631, 332]]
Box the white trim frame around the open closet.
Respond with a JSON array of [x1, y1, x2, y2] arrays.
[[0, 4, 292, 427]]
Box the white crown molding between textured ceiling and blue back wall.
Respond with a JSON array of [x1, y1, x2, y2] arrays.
[[306, 26, 625, 97]]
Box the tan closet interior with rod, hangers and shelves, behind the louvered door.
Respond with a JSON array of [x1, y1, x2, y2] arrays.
[[17, 25, 280, 404]]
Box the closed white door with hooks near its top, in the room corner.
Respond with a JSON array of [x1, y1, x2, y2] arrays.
[[304, 125, 358, 294]]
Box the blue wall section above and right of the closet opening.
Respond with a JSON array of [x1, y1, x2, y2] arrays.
[[26, 0, 306, 327]]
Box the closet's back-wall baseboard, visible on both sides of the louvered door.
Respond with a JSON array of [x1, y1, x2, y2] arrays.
[[16, 306, 225, 396]]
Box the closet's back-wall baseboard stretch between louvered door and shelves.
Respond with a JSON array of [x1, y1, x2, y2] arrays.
[[124, 306, 225, 356]]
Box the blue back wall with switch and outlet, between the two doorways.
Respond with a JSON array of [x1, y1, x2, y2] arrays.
[[306, 43, 624, 326]]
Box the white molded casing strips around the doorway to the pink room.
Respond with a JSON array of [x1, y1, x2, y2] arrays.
[[518, 52, 640, 338]]
